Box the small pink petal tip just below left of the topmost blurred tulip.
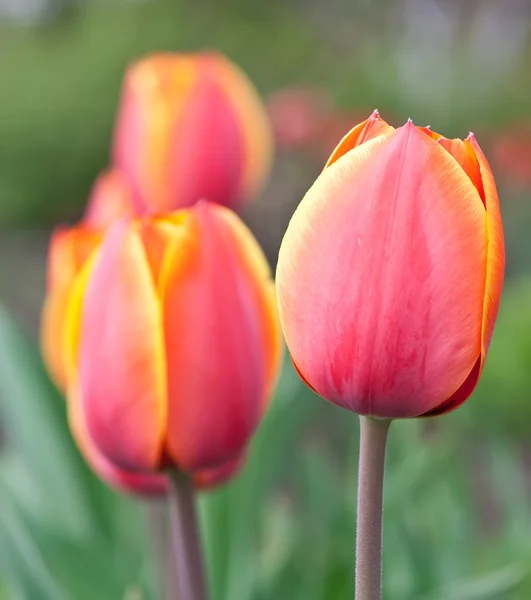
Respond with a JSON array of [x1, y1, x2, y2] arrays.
[[83, 169, 135, 231]]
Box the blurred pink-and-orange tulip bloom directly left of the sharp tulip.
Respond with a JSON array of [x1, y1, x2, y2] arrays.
[[59, 202, 282, 487]]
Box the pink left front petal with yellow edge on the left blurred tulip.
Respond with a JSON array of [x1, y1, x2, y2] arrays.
[[79, 220, 166, 471]]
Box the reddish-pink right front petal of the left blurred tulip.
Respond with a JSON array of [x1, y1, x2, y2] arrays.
[[159, 202, 267, 472]]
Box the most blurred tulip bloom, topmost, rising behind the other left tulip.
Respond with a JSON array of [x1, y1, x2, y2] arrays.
[[113, 52, 272, 213]]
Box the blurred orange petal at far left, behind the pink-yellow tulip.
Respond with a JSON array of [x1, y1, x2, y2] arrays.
[[41, 227, 100, 392]]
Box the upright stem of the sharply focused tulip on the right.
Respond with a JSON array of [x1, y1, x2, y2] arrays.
[[355, 416, 391, 600]]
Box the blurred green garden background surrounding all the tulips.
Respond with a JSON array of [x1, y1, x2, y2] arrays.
[[0, 0, 531, 600]]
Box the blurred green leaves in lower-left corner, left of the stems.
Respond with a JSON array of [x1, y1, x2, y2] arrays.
[[0, 310, 158, 600]]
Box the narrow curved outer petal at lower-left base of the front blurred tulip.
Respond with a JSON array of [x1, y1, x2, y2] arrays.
[[68, 384, 169, 496]]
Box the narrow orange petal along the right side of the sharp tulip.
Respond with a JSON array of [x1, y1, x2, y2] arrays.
[[469, 134, 505, 362]]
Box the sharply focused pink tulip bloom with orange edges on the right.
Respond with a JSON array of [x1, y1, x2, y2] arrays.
[[277, 113, 505, 418]]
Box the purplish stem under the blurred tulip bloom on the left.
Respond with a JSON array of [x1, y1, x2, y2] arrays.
[[170, 471, 207, 600]]
